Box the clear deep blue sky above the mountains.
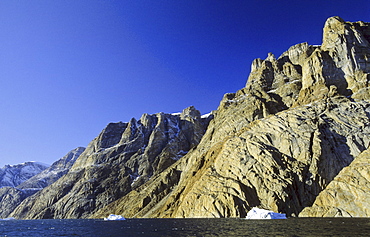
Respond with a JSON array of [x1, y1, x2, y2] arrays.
[[0, 0, 370, 167]]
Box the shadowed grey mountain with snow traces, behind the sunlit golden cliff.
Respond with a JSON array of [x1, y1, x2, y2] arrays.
[[10, 107, 212, 219]]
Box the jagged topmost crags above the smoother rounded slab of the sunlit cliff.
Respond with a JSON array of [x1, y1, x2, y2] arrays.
[[239, 17, 370, 109]]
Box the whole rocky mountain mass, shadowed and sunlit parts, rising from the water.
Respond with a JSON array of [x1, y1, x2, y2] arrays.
[[1, 17, 370, 219]]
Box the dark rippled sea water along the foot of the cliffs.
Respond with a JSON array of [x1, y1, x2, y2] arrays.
[[0, 218, 370, 236]]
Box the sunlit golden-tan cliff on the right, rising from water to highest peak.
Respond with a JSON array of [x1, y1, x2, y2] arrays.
[[91, 17, 370, 217]]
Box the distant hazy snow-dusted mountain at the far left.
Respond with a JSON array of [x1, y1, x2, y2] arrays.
[[0, 161, 49, 187]]
